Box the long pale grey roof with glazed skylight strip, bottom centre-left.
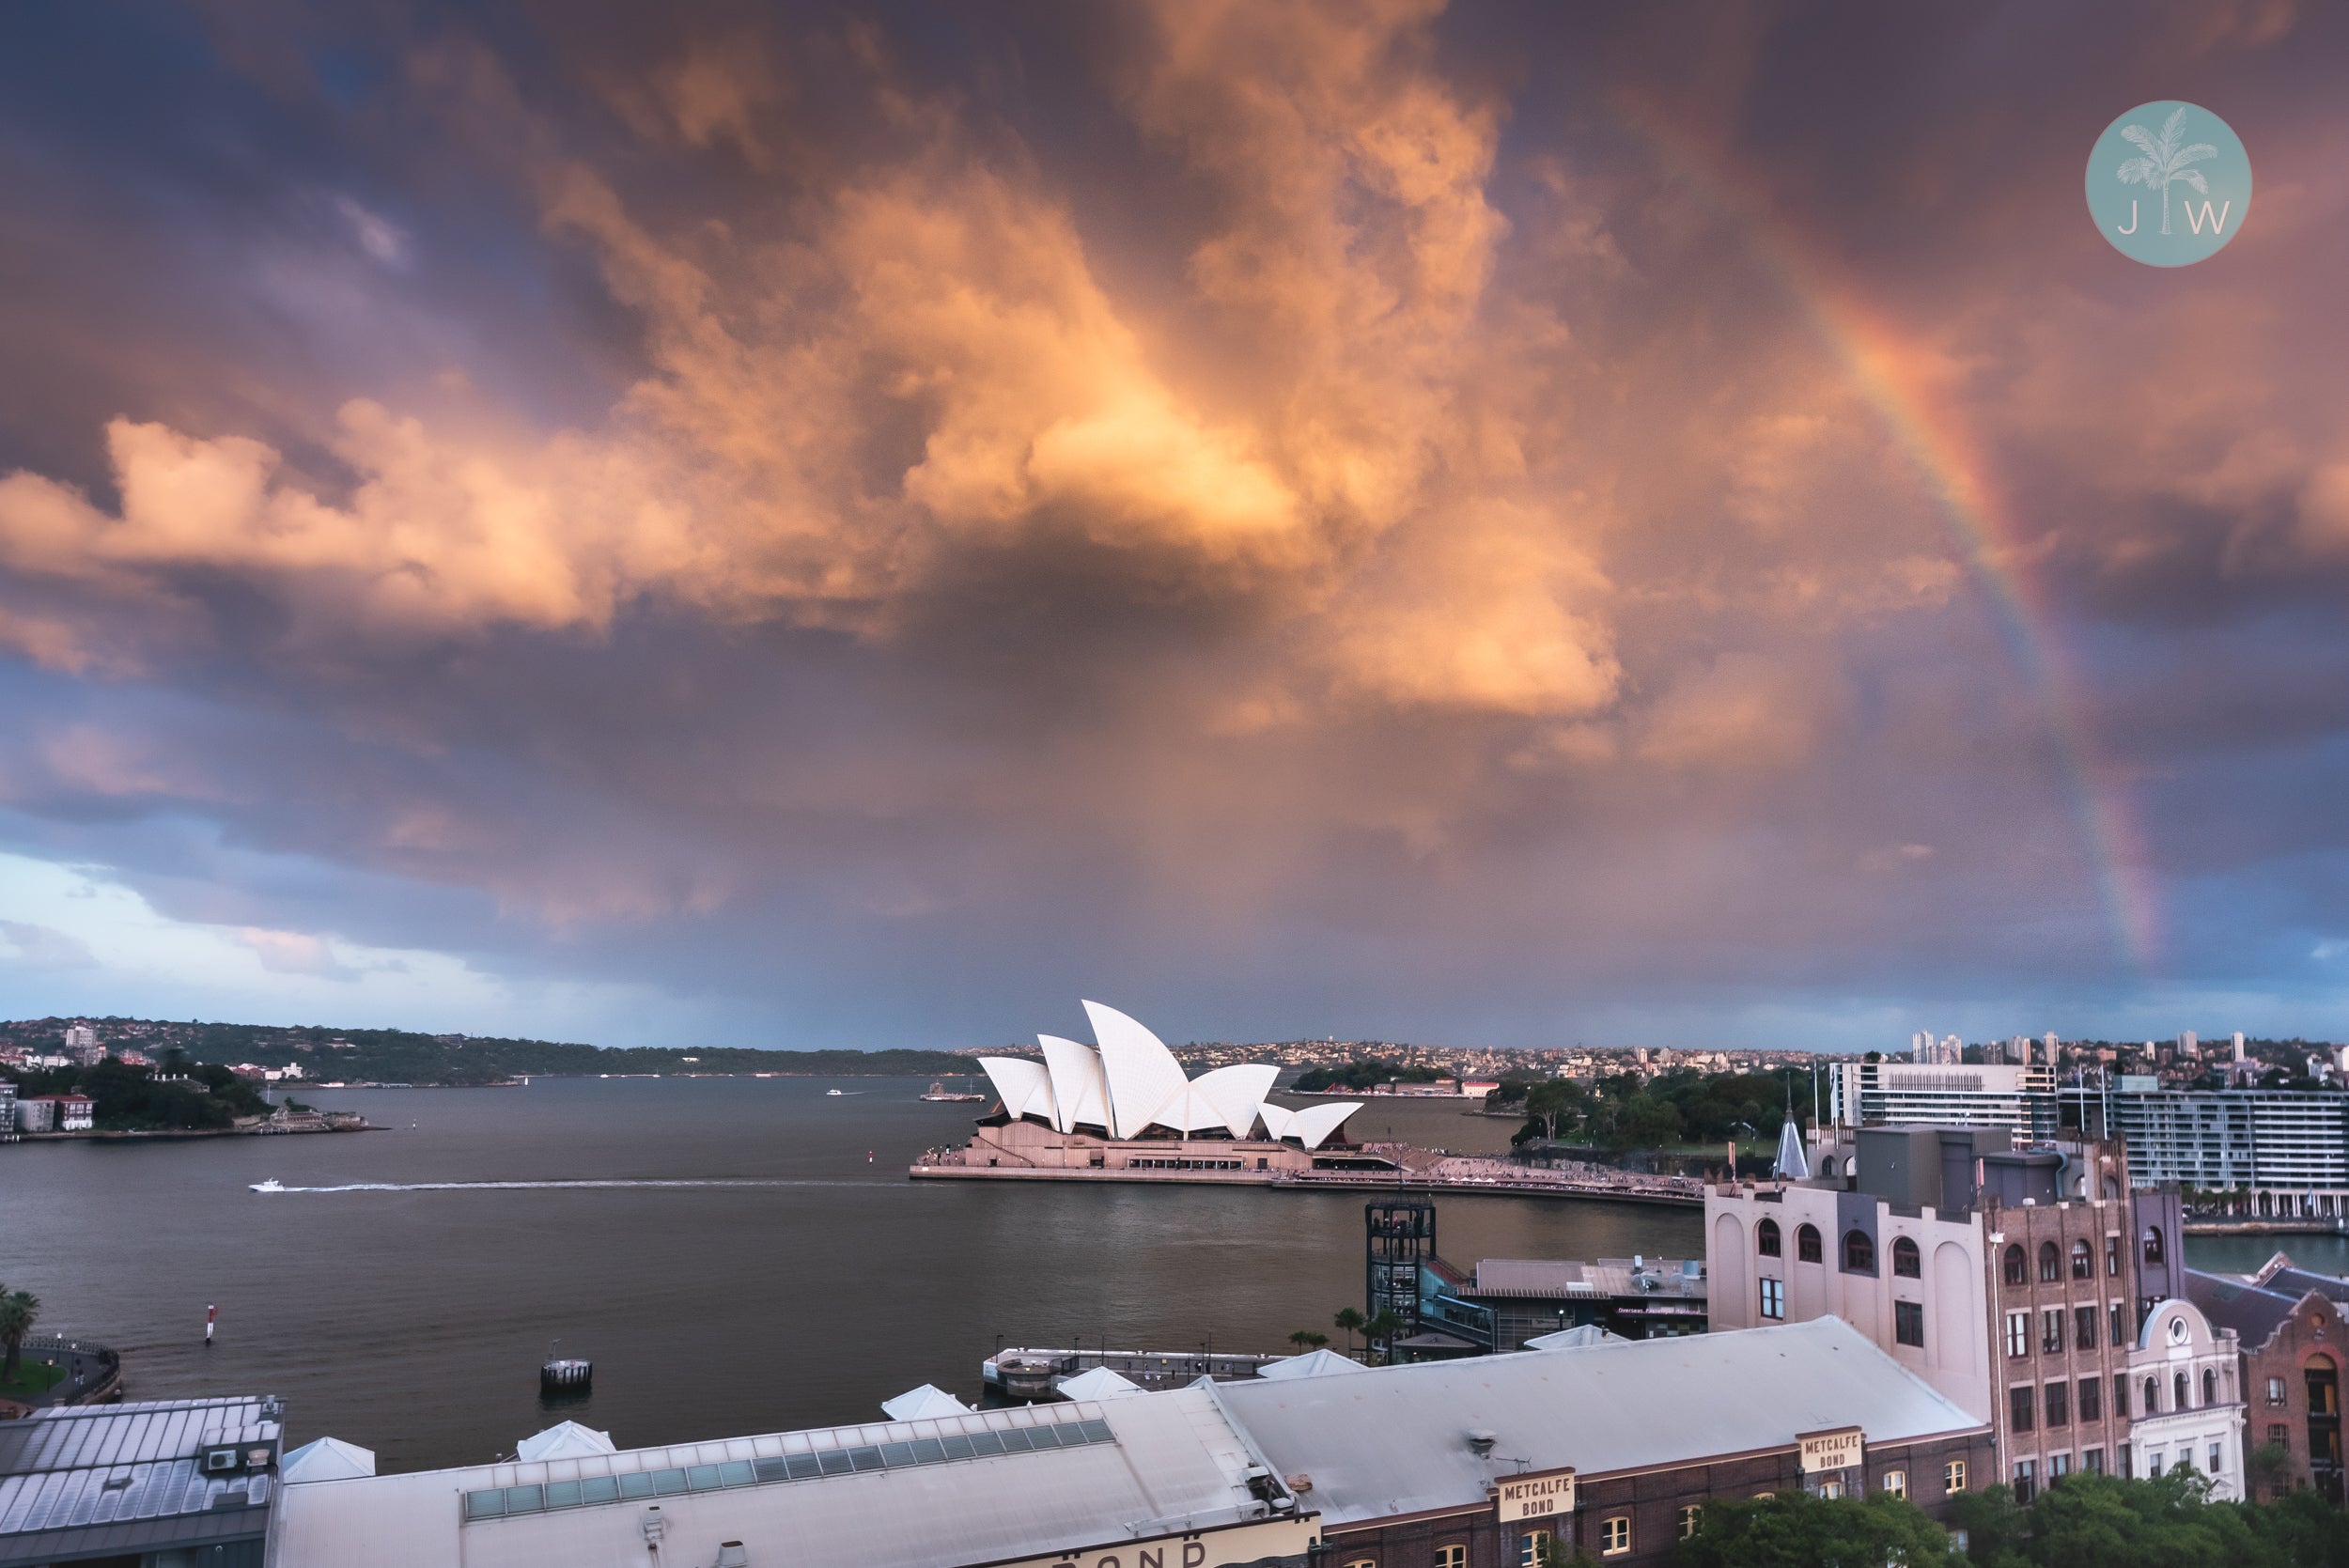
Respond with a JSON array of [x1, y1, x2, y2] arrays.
[[272, 1388, 1306, 1568]]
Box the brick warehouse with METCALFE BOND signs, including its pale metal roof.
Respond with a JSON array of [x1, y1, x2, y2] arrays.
[[1217, 1317, 1997, 1568]]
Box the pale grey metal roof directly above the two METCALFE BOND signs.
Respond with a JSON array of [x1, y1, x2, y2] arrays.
[[1215, 1317, 1983, 1526]]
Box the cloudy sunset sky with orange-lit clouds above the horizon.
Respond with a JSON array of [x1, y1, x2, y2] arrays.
[[0, 0, 2349, 1049]]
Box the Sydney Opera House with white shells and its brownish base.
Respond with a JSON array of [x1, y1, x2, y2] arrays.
[[916, 1002, 1389, 1176]]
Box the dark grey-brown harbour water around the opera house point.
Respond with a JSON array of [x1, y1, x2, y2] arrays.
[[0, 1078, 1701, 1469]]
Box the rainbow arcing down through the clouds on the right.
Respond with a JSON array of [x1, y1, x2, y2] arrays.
[[1611, 89, 2159, 976]]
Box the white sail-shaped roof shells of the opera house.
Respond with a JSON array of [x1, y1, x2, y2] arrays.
[[980, 1002, 1362, 1148]]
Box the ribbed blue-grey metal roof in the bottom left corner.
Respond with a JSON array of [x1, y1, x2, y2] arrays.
[[0, 1399, 277, 1561]]
